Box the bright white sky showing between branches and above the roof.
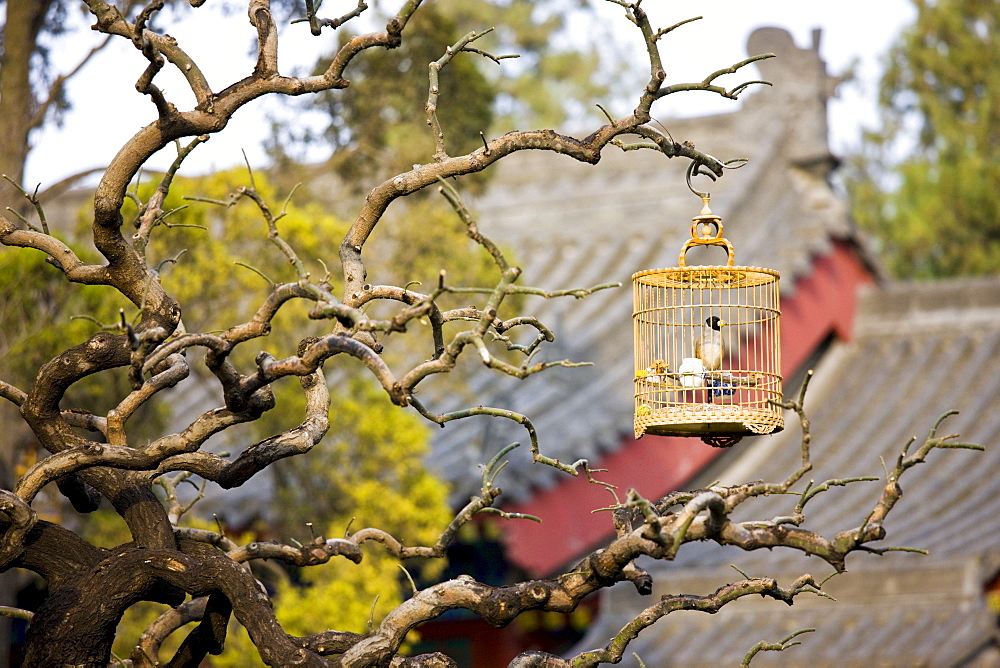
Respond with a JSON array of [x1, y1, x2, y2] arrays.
[[25, 0, 914, 189]]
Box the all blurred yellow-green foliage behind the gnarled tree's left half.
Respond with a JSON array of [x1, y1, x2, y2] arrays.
[[7, 169, 484, 666]]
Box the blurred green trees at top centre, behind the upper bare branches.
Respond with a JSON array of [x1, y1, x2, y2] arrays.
[[269, 0, 618, 187]]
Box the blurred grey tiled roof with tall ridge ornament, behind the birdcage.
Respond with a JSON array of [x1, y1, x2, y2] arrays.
[[424, 28, 855, 500]]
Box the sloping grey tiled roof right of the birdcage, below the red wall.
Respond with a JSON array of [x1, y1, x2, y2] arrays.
[[664, 278, 1000, 568]]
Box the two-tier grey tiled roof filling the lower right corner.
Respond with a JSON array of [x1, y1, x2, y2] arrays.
[[582, 277, 1000, 666]]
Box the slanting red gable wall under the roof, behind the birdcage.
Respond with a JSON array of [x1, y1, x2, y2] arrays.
[[504, 242, 873, 577]]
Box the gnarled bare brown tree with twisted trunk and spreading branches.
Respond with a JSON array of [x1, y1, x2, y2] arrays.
[[0, 0, 981, 666]]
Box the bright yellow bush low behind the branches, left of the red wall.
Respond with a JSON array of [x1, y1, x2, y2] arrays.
[[213, 379, 450, 667]]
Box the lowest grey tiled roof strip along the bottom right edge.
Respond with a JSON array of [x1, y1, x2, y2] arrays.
[[588, 562, 997, 668]]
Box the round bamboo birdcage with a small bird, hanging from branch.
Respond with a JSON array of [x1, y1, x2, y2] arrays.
[[632, 194, 784, 447]]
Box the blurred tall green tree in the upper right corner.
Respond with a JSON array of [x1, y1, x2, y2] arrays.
[[848, 0, 1000, 278]]
